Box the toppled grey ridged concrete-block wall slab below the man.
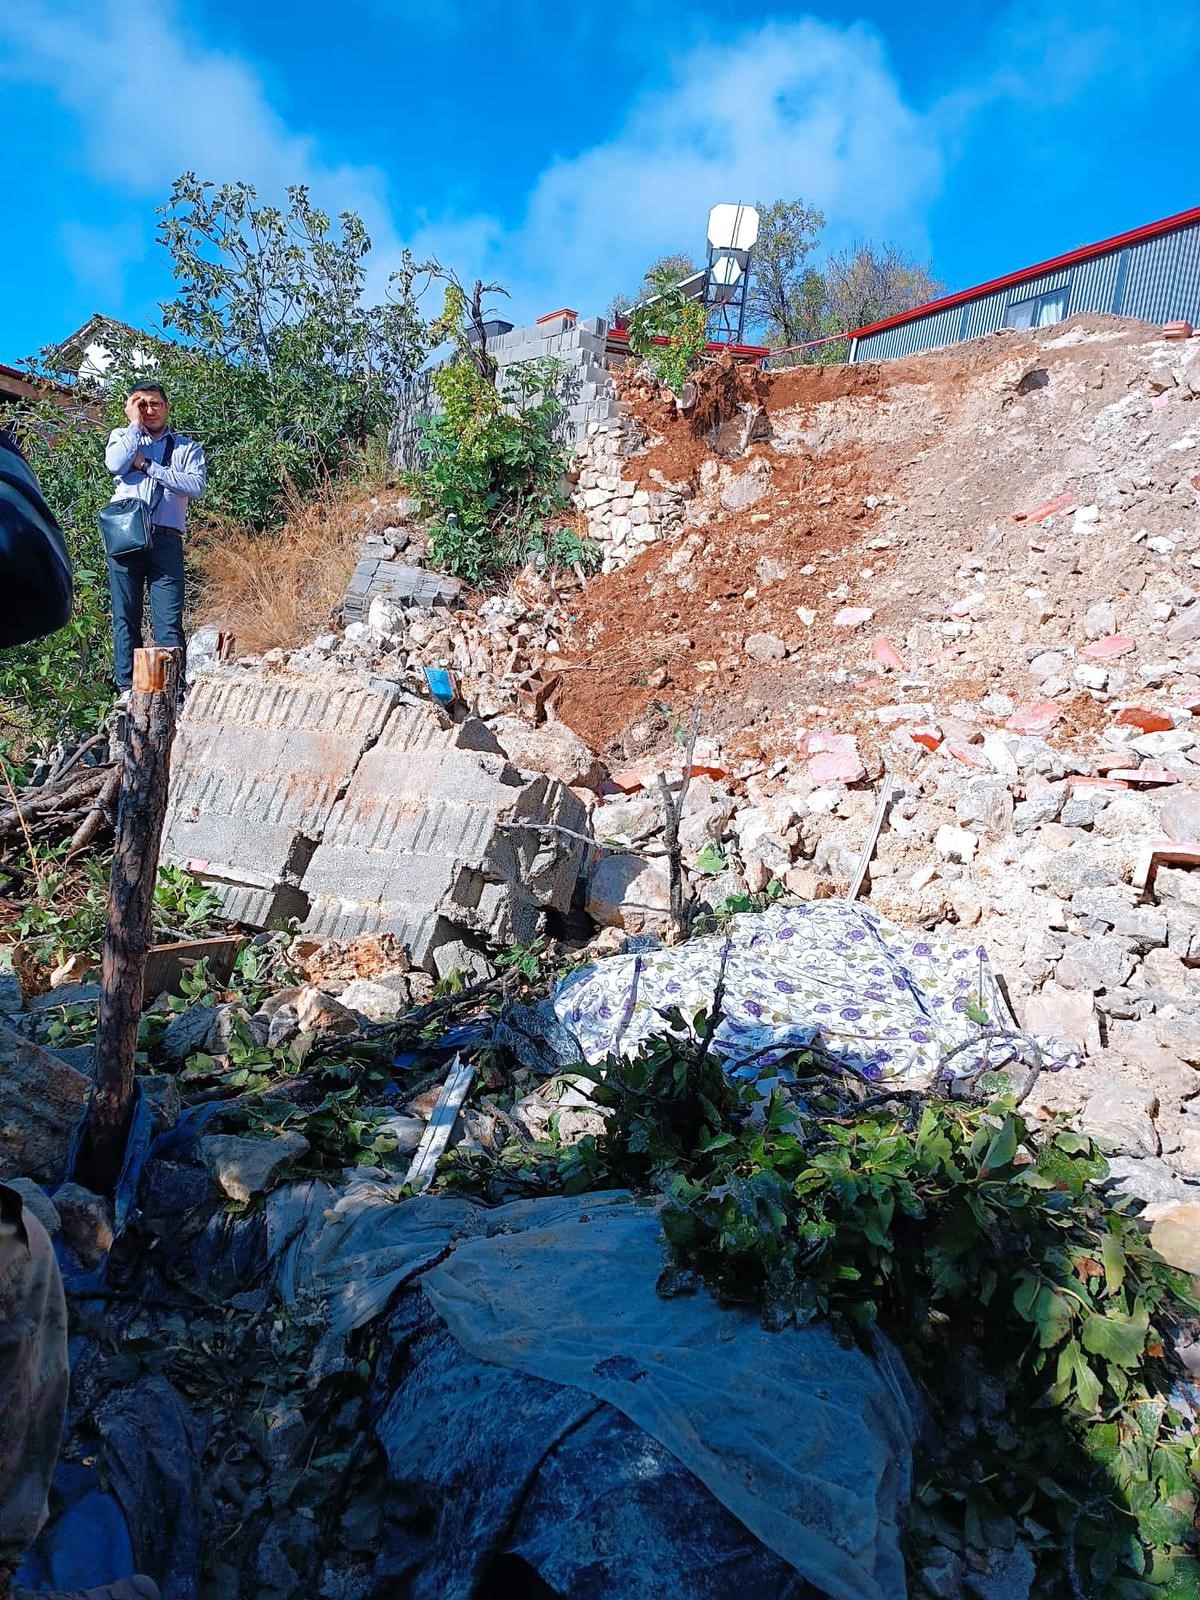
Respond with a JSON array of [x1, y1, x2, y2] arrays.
[[163, 664, 586, 971]]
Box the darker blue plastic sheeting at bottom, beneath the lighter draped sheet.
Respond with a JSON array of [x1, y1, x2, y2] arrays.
[[370, 1286, 819, 1600]]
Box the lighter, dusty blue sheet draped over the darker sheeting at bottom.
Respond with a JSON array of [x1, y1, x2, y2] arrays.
[[267, 1182, 917, 1600]]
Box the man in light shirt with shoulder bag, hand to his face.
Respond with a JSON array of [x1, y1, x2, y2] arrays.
[[104, 381, 206, 704]]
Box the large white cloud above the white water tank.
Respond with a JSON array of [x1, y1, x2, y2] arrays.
[[430, 19, 941, 321]]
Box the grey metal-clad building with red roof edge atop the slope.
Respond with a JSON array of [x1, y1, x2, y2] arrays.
[[850, 206, 1200, 362]]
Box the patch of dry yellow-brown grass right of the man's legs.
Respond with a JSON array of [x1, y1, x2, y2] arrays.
[[194, 483, 370, 654]]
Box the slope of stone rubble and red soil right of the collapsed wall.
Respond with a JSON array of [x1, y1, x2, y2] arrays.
[[171, 317, 1200, 1222]]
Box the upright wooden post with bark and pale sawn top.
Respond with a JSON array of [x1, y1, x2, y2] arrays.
[[75, 650, 179, 1194]]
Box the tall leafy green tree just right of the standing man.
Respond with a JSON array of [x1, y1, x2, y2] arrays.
[[147, 173, 435, 526]]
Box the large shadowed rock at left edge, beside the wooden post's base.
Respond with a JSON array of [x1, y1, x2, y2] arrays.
[[0, 1027, 91, 1184]]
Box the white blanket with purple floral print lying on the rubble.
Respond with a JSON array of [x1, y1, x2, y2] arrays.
[[549, 901, 1072, 1088]]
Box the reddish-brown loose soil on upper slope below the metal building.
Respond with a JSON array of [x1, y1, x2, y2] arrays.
[[555, 317, 1200, 760]]
